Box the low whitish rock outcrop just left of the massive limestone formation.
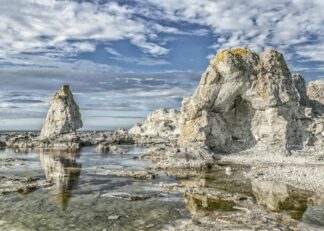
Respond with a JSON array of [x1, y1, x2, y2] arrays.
[[128, 108, 180, 143]]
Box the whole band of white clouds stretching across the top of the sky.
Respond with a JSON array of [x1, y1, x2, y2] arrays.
[[0, 0, 324, 61]]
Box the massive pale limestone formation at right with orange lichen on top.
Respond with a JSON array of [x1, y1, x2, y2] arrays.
[[179, 48, 324, 153]]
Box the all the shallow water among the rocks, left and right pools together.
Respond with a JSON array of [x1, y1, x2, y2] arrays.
[[0, 146, 324, 230]]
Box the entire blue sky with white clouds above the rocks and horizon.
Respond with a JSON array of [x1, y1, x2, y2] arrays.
[[0, 0, 324, 130]]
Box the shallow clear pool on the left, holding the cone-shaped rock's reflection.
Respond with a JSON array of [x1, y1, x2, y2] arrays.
[[0, 147, 189, 230]]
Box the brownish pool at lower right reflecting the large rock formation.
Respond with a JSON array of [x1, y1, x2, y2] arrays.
[[177, 165, 324, 230]]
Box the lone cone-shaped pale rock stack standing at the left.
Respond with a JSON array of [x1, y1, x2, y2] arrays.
[[40, 85, 82, 138]]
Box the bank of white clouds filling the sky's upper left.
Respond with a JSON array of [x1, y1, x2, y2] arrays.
[[0, 0, 172, 56]]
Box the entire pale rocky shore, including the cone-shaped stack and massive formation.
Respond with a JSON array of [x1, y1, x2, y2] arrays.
[[0, 48, 324, 230]]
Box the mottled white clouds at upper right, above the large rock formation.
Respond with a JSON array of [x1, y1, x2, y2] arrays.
[[146, 0, 324, 61]]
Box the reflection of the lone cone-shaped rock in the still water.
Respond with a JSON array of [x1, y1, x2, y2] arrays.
[[39, 150, 82, 209]]
